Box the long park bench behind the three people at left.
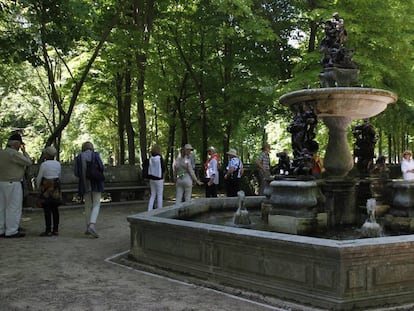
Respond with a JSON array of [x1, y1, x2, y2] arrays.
[[24, 164, 149, 206]]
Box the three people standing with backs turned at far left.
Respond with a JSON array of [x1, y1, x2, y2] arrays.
[[0, 133, 104, 238]]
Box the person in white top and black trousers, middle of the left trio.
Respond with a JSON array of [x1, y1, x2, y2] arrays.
[[36, 146, 62, 236]]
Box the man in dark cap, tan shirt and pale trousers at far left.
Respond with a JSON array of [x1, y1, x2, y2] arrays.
[[0, 133, 32, 238]]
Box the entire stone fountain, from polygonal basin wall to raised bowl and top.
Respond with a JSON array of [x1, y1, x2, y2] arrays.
[[126, 16, 414, 310]]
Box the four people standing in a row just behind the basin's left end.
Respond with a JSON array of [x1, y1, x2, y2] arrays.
[[148, 144, 243, 211]]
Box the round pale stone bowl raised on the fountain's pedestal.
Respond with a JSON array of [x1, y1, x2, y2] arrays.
[[279, 87, 398, 120]]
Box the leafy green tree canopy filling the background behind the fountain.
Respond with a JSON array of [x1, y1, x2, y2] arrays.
[[0, 0, 414, 167]]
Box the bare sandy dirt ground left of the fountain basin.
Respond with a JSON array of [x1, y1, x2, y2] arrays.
[[0, 202, 308, 311]]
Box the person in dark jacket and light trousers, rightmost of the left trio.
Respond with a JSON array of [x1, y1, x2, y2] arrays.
[[75, 141, 104, 238]]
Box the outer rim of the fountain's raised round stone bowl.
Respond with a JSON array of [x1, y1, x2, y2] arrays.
[[279, 87, 398, 106]]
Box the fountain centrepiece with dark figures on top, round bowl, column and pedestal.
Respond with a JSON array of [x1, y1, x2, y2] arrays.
[[267, 15, 397, 233]]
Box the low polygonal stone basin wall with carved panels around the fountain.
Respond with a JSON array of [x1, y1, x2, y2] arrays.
[[128, 197, 414, 310]]
